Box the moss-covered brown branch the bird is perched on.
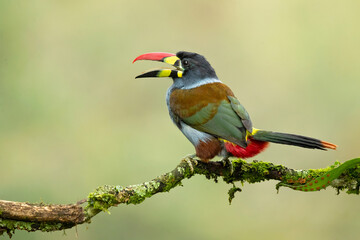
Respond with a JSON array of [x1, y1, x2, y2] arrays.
[[0, 157, 360, 236]]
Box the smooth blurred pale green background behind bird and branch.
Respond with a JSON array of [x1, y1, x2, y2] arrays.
[[0, 0, 360, 240]]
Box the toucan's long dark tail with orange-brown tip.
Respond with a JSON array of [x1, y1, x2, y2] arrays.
[[252, 130, 337, 150]]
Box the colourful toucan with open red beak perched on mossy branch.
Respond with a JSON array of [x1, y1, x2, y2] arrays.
[[133, 51, 337, 162]]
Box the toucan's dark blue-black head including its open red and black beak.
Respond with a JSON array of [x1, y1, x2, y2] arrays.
[[133, 51, 217, 86]]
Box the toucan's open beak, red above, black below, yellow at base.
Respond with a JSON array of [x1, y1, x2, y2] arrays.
[[133, 52, 184, 78]]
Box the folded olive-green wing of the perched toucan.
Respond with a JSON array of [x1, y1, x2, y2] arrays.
[[182, 97, 252, 147]]
